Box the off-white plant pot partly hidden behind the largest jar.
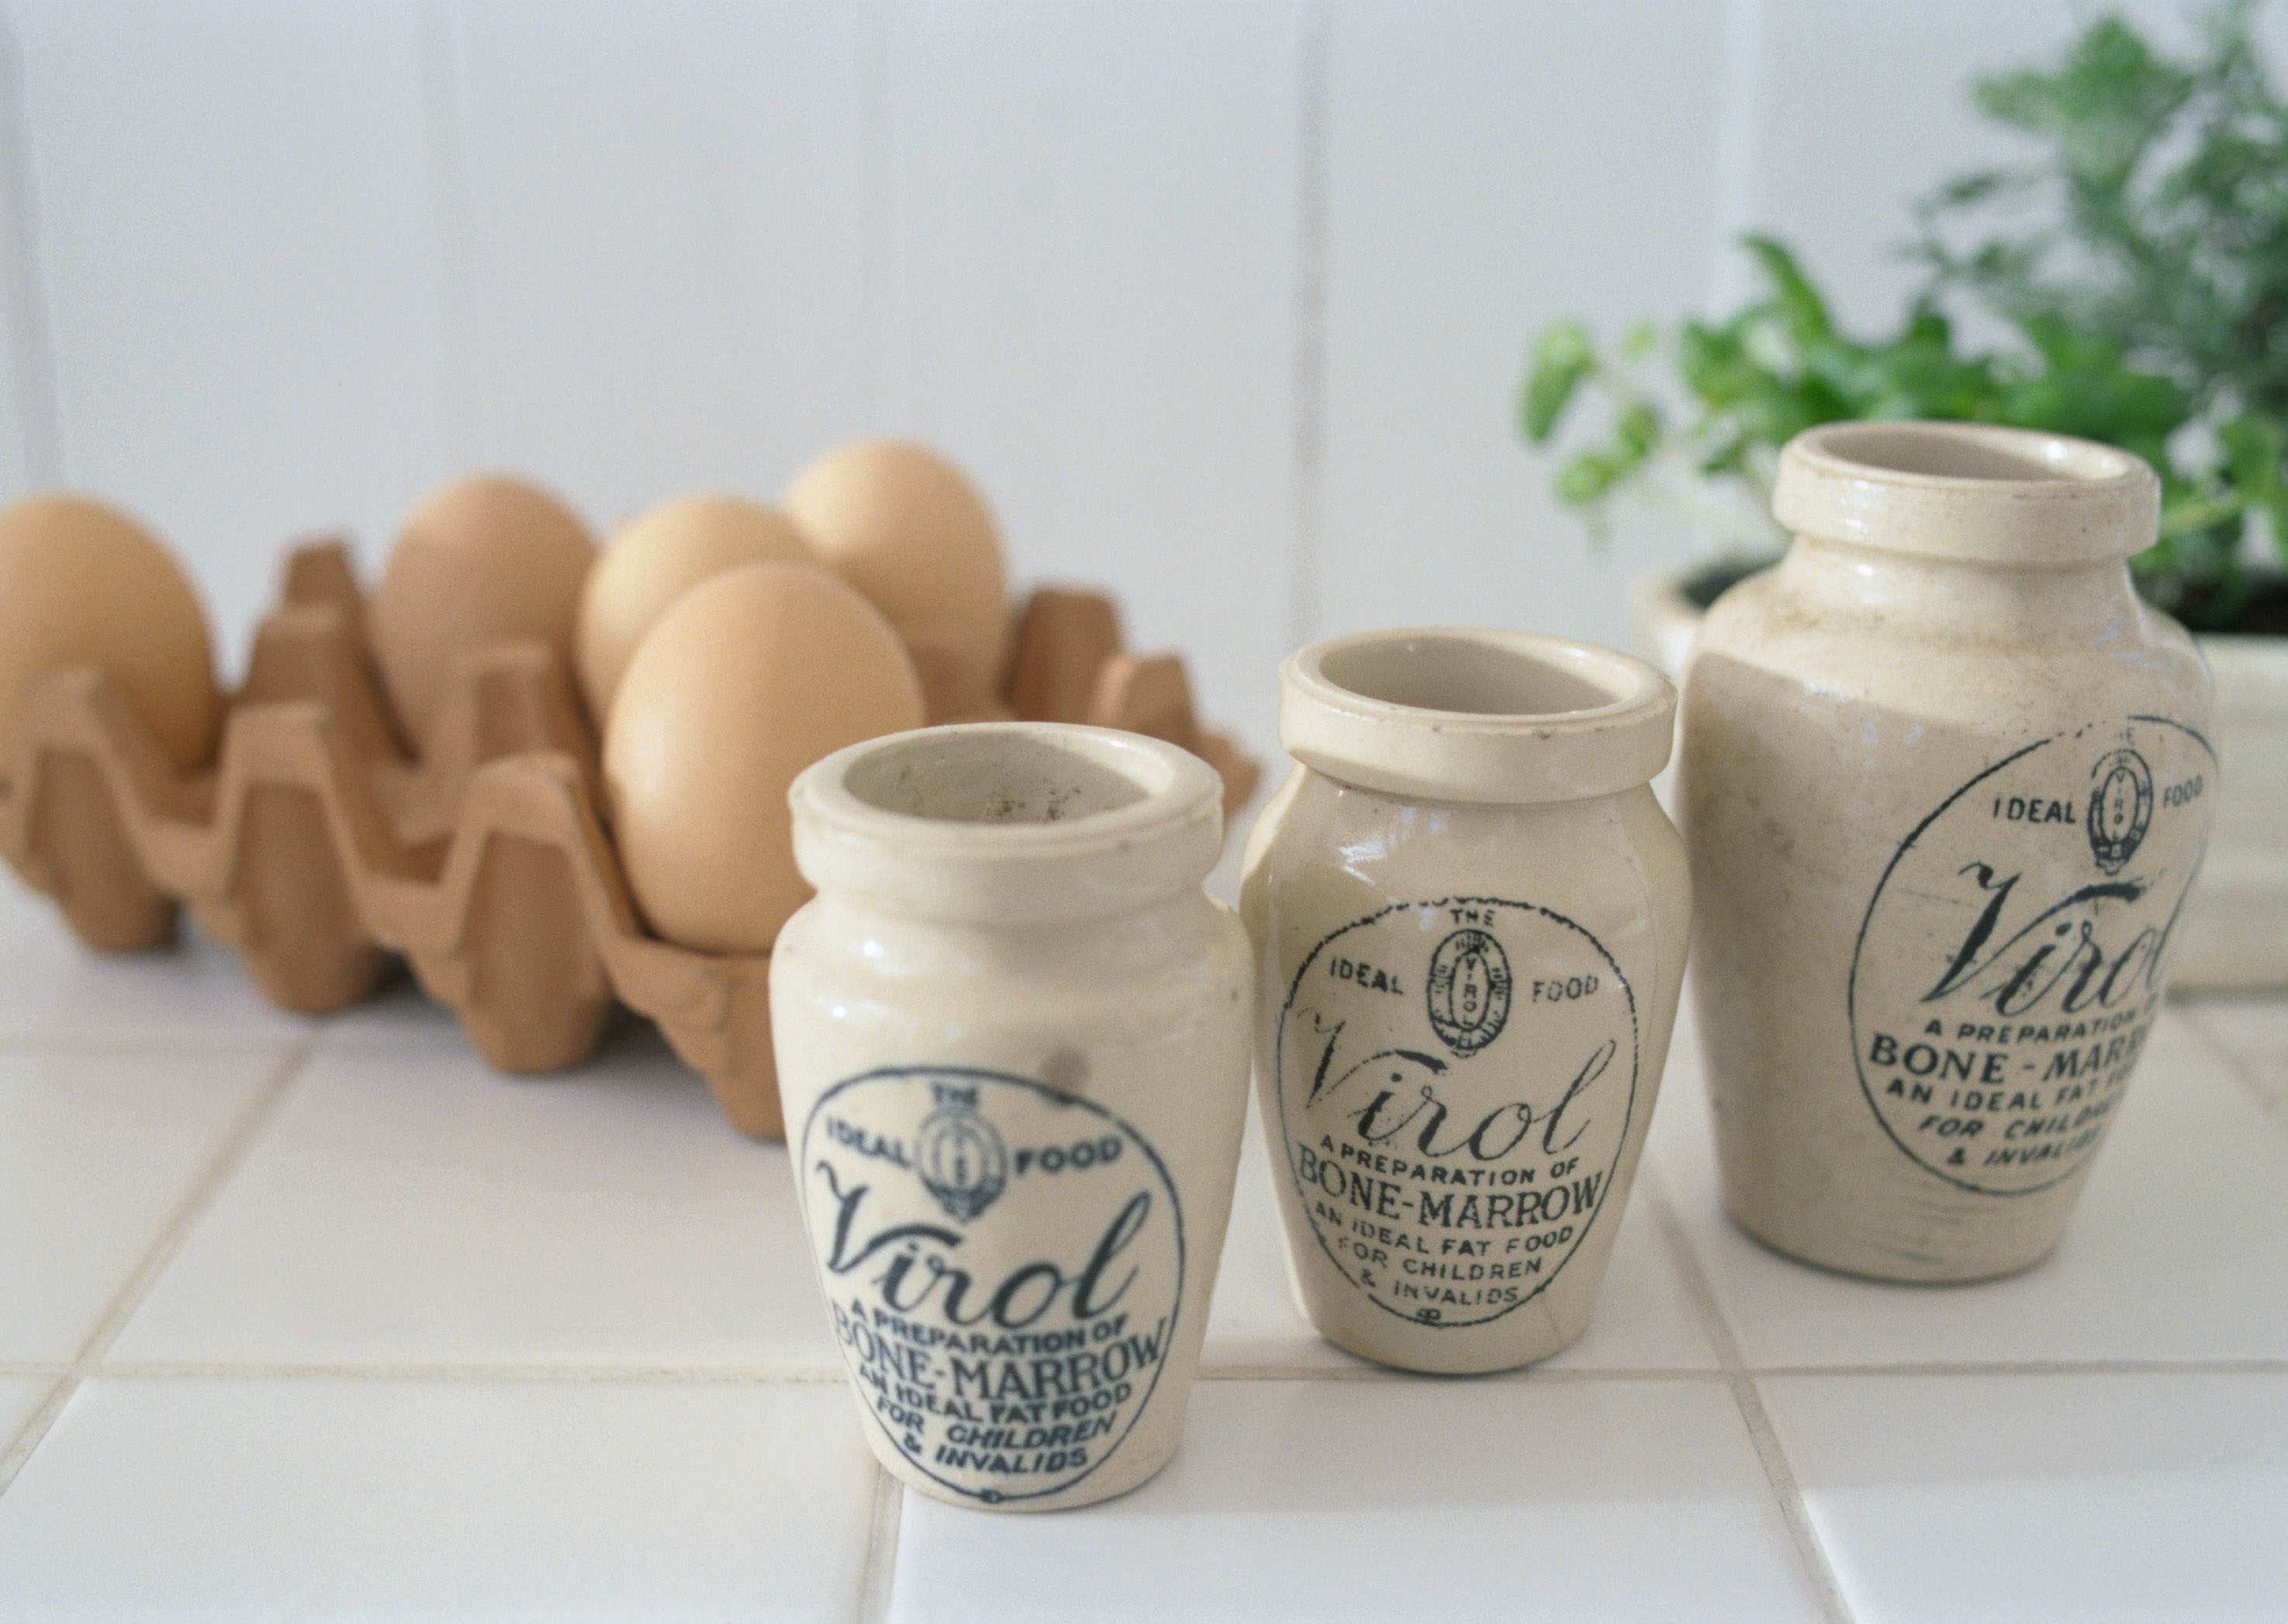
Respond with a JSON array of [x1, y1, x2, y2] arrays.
[[1629, 565, 2288, 993]]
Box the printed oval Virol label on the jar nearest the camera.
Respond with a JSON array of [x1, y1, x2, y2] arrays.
[[801, 1066, 1185, 1505]]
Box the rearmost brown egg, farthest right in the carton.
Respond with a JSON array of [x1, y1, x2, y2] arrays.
[[780, 439, 1009, 723]]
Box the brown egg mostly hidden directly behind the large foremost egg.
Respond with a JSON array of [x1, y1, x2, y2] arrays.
[[576, 496, 819, 718]]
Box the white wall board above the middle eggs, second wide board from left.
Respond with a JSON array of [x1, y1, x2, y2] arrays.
[[453, 0, 888, 507]]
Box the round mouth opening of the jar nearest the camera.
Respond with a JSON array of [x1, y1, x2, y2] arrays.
[[842, 727, 1169, 826]]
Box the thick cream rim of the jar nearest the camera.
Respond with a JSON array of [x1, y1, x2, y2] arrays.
[[787, 720, 1224, 922]]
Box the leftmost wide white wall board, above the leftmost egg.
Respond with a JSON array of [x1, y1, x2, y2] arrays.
[[7, 0, 455, 672]]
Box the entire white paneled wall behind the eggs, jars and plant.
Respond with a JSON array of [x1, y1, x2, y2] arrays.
[[0, 0, 2251, 750]]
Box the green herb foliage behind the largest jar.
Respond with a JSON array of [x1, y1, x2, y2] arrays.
[[1519, 0, 2288, 624]]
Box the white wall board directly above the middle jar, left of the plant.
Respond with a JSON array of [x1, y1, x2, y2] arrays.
[[1302, 0, 1725, 643]]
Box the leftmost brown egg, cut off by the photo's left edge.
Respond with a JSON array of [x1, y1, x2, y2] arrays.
[[0, 496, 222, 783]]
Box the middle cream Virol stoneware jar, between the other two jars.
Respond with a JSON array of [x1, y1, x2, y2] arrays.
[[1240, 631, 1691, 1373]]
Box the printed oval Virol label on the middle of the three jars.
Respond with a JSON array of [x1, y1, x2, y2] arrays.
[[1274, 897, 1638, 1327]]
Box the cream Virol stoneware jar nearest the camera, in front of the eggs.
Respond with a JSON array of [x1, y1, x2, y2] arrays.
[[771, 723, 1252, 1510]]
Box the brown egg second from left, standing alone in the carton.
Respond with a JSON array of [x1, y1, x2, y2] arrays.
[[371, 475, 595, 748]]
